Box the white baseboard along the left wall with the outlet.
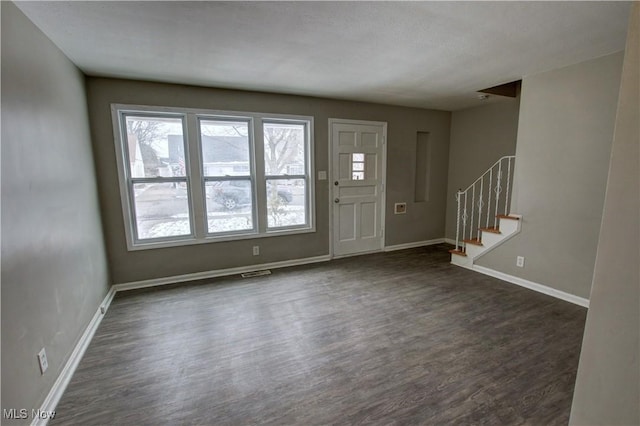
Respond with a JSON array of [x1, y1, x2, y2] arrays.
[[31, 286, 116, 426]]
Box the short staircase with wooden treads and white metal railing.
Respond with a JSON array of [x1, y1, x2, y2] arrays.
[[450, 155, 522, 268]]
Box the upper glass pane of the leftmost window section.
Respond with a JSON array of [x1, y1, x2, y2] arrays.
[[126, 116, 186, 178]]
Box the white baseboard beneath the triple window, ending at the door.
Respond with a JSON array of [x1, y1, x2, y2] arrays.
[[113, 255, 331, 291]]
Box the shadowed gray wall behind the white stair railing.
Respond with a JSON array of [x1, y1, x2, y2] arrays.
[[445, 98, 520, 239]]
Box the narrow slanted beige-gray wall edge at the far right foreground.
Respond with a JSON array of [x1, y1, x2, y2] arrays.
[[569, 3, 640, 425]]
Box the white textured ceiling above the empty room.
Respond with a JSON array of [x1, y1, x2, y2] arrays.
[[16, 1, 630, 110]]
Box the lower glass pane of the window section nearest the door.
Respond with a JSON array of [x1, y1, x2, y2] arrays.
[[267, 179, 307, 228]]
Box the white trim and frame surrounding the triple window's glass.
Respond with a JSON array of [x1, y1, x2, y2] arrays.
[[111, 104, 316, 251]]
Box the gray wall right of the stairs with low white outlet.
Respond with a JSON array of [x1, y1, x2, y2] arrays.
[[478, 52, 623, 298]]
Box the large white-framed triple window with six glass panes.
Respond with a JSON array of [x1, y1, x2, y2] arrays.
[[112, 105, 314, 249]]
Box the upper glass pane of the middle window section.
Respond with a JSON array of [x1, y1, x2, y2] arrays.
[[200, 120, 251, 176]]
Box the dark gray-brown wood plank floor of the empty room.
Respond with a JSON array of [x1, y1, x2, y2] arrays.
[[50, 245, 586, 425]]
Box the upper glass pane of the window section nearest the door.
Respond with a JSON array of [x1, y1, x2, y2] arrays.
[[263, 123, 305, 176]]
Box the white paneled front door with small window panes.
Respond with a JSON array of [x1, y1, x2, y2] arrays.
[[329, 119, 387, 256]]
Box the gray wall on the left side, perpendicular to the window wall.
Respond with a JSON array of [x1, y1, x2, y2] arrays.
[[1, 1, 109, 424]]
